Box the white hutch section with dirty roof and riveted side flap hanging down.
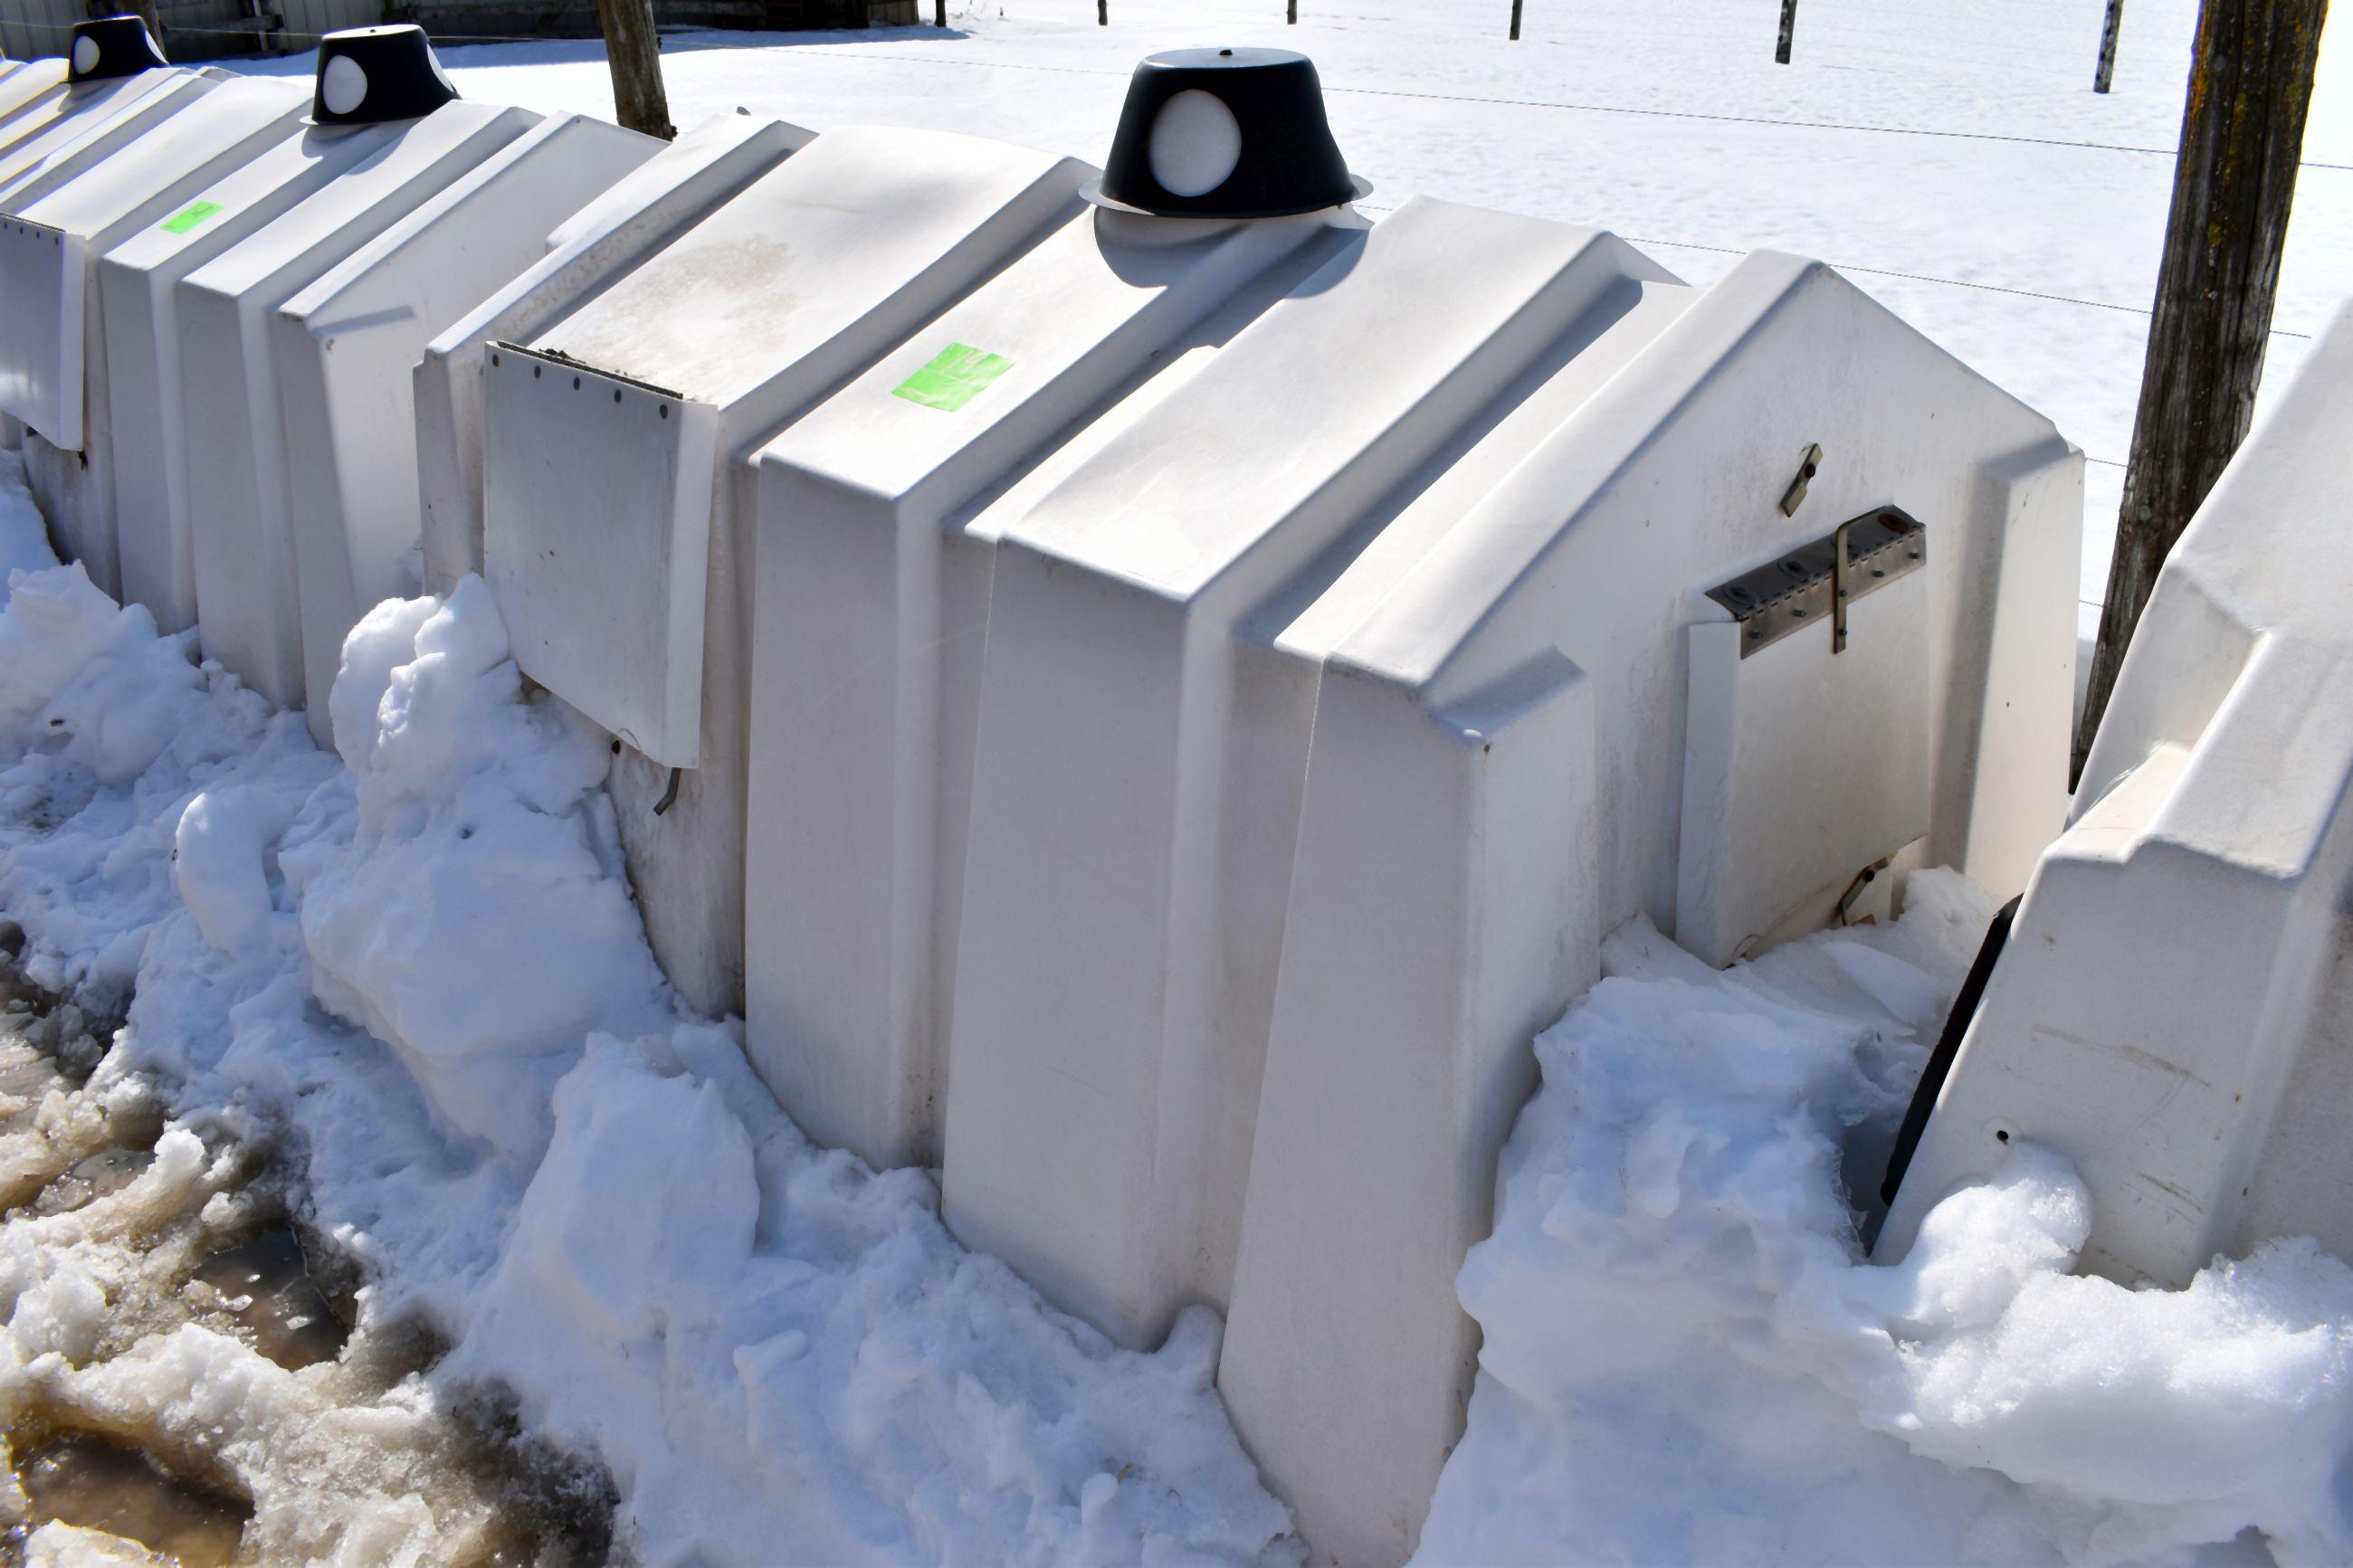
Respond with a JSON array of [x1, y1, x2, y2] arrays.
[[482, 129, 1085, 1011]]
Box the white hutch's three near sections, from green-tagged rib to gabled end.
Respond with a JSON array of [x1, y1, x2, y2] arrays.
[[753, 56, 2082, 1561]]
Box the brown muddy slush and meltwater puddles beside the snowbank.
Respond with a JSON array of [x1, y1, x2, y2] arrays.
[[0, 956, 614, 1568]]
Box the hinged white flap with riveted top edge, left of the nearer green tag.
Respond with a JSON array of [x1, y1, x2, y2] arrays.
[[485, 343, 720, 766]]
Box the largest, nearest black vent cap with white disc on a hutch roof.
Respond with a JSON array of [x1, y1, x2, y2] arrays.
[[1085, 50, 1372, 219]]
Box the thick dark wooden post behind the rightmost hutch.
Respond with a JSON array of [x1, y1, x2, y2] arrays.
[[2075, 0, 2329, 774]]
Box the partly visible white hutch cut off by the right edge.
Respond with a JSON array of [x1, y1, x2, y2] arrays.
[[1875, 310, 2353, 1286]]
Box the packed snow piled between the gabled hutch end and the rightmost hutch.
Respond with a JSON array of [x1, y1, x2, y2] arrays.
[[1421, 872, 2353, 1563]]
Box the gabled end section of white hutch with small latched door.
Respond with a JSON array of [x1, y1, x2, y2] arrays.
[[1214, 254, 2082, 1561]]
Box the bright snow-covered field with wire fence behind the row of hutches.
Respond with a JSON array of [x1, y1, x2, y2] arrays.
[[233, 0, 2353, 630]]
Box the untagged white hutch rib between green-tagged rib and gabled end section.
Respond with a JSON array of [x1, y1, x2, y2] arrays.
[[944, 200, 1663, 1345]]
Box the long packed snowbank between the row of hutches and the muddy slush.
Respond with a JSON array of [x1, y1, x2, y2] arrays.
[[0, 500, 1290, 1563]]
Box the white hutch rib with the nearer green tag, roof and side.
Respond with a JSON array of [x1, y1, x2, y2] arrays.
[[746, 209, 1356, 1166]]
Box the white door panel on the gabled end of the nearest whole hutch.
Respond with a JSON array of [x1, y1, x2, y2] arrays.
[[1675, 543, 1934, 964]]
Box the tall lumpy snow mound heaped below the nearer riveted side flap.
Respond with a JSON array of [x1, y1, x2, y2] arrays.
[[282, 578, 671, 1155]]
